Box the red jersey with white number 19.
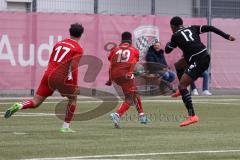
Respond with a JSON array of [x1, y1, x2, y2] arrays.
[[108, 43, 139, 79]]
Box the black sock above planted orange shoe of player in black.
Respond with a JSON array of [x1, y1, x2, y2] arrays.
[[179, 88, 195, 116]]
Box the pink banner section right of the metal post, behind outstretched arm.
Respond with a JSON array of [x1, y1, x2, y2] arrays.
[[211, 19, 240, 88]]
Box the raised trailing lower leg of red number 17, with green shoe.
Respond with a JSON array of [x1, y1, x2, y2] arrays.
[[4, 95, 46, 118]]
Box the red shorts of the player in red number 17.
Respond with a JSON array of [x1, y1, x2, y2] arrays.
[[36, 73, 78, 97]]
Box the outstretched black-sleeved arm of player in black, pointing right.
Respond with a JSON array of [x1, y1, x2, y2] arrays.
[[201, 25, 236, 41]]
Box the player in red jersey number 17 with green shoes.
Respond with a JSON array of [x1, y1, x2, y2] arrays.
[[5, 23, 84, 132]]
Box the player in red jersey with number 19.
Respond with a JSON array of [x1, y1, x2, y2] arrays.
[[107, 32, 148, 128]]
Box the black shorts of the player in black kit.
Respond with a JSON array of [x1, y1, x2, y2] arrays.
[[185, 53, 210, 80]]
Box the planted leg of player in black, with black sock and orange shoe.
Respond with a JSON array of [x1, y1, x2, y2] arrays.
[[179, 73, 199, 127]]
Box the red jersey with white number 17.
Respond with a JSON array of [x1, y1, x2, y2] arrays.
[[45, 38, 83, 84]]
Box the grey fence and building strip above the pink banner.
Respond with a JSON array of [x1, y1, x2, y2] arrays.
[[0, 0, 240, 18]]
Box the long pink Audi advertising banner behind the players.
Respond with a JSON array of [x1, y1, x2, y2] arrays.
[[0, 12, 237, 89]]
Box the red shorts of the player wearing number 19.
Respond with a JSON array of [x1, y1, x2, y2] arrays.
[[113, 79, 137, 94]]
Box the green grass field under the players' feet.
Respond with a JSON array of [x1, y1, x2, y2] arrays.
[[0, 96, 240, 160]]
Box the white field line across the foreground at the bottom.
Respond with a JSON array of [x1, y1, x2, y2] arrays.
[[25, 150, 240, 160]]
